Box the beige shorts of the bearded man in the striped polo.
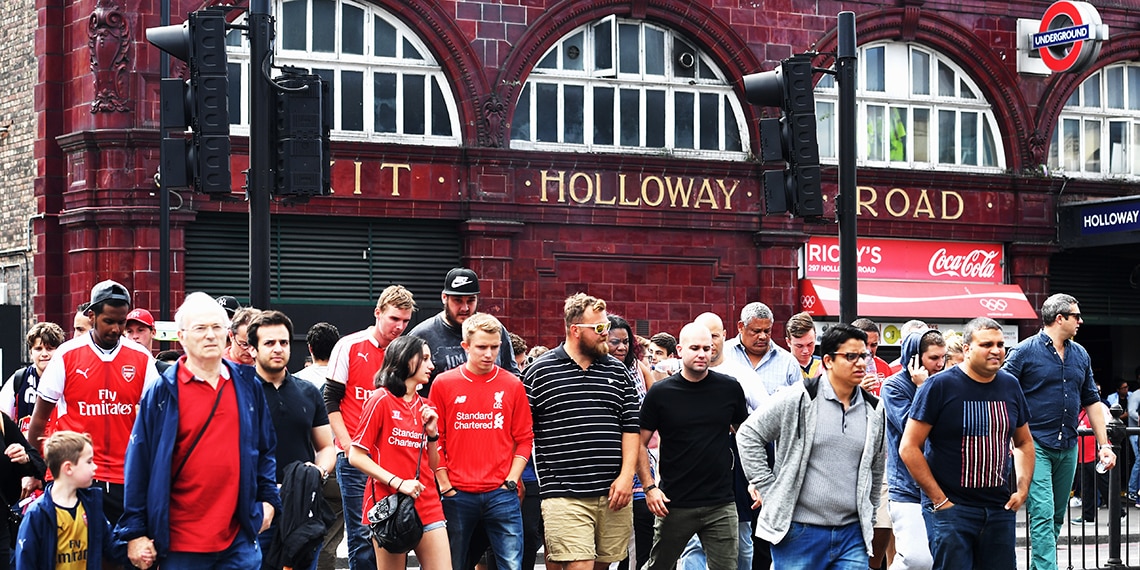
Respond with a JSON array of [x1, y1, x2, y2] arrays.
[[543, 497, 634, 562]]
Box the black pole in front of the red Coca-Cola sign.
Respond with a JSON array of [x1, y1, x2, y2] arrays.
[[836, 11, 858, 323]]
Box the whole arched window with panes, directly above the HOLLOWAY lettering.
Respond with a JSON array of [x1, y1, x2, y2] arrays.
[[511, 16, 748, 160]]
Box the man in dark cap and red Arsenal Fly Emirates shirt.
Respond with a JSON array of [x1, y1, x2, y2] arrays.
[[27, 280, 158, 524]]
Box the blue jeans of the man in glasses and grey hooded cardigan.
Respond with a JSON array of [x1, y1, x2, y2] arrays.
[[772, 522, 861, 570]]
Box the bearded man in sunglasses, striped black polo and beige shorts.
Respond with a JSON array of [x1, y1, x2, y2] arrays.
[[522, 293, 652, 570]]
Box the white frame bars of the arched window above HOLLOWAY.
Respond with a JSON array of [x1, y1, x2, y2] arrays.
[[511, 15, 750, 161]]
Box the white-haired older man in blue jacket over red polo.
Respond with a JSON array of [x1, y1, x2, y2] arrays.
[[116, 293, 280, 570]]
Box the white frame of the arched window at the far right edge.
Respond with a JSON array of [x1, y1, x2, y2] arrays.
[[1047, 63, 1140, 180]]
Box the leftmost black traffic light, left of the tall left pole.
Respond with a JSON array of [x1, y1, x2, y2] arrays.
[[146, 9, 230, 194]]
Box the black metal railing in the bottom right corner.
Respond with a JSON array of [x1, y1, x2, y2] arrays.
[[1019, 405, 1140, 570]]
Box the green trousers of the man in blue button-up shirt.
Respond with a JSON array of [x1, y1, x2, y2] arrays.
[[1025, 440, 1077, 570]]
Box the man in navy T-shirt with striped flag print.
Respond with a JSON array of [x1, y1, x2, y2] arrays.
[[899, 317, 1034, 569]]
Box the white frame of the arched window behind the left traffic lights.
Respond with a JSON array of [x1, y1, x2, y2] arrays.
[[227, 0, 462, 146]]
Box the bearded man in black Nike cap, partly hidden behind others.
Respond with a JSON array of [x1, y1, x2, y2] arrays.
[[408, 267, 520, 397]]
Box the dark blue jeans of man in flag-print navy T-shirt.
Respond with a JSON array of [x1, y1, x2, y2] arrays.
[[922, 505, 1017, 570]]
